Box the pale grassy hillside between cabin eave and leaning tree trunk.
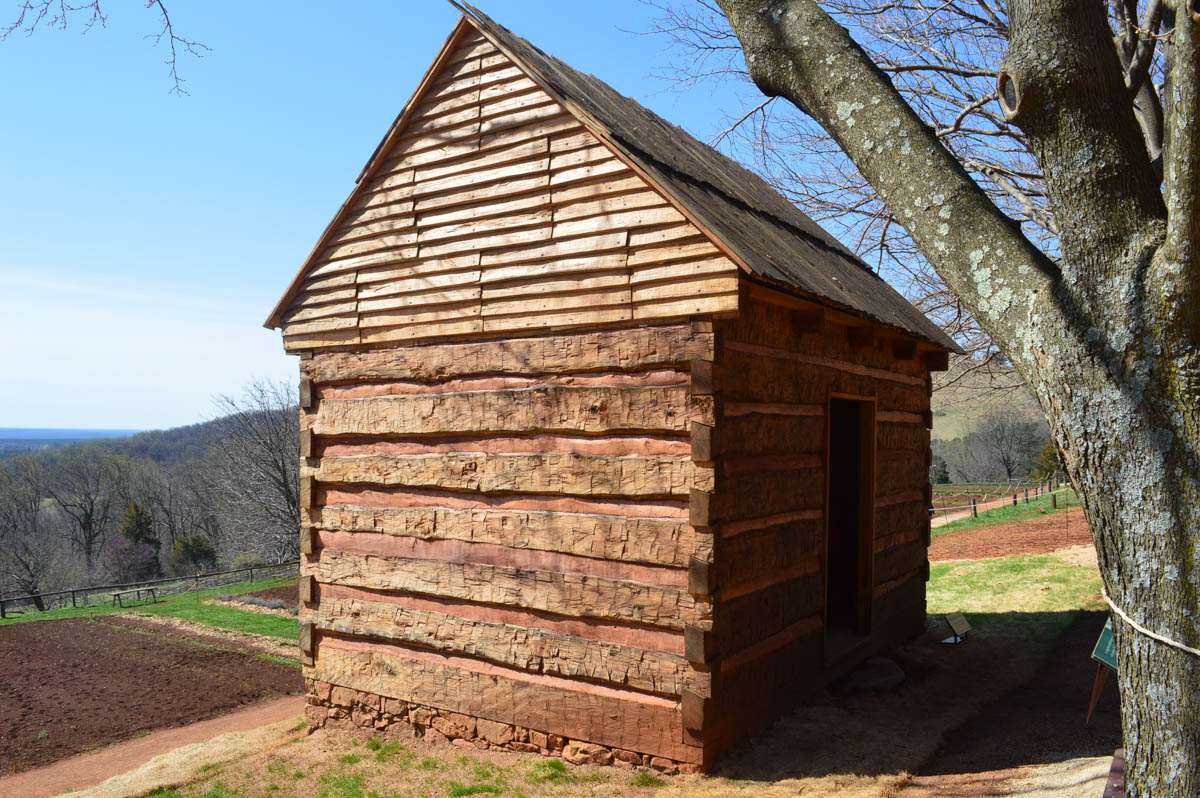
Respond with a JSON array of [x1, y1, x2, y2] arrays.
[[930, 367, 1043, 440]]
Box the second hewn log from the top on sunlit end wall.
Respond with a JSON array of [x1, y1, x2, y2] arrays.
[[312, 385, 714, 436]]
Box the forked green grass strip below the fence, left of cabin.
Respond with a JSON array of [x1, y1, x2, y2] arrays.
[[0, 577, 300, 640]]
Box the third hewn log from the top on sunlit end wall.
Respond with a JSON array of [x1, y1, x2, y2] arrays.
[[313, 452, 713, 497]]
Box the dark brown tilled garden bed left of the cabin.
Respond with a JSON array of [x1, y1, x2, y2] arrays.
[[0, 618, 304, 773]]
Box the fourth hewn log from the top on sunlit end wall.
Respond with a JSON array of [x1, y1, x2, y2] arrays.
[[320, 505, 713, 566]]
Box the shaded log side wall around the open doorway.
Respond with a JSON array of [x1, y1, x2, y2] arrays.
[[684, 291, 930, 758]]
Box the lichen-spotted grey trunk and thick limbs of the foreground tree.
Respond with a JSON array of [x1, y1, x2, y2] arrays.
[[719, 0, 1200, 798]]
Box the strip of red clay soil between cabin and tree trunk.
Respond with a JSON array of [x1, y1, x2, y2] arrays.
[[929, 508, 1092, 563]]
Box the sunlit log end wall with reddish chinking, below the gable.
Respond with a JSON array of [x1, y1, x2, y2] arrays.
[[301, 324, 715, 767]]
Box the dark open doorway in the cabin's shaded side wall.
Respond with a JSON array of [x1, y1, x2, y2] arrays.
[[826, 396, 875, 635]]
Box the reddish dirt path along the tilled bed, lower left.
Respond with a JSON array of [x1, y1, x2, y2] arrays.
[[0, 696, 304, 798]]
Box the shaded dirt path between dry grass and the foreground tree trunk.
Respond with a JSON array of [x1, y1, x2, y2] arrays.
[[900, 612, 1121, 798]]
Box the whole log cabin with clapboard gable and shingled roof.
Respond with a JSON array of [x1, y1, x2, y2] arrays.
[[266, 7, 955, 773]]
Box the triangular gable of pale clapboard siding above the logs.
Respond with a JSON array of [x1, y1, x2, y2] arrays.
[[283, 33, 738, 352]]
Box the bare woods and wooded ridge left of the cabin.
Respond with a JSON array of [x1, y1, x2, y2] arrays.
[[0, 382, 300, 595]]
